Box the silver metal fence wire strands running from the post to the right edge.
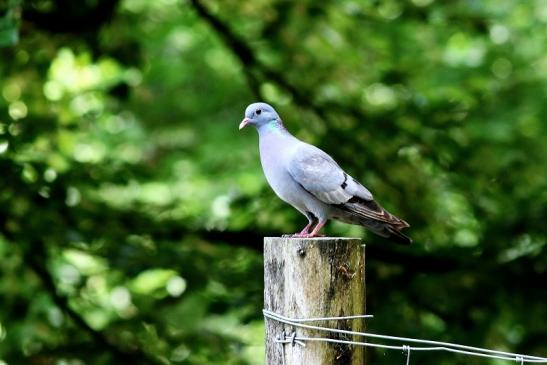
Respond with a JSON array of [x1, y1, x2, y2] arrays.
[[263, 309, 547, 365]]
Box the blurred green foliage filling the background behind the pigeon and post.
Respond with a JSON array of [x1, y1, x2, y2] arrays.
[[0, 0, 547, 364]]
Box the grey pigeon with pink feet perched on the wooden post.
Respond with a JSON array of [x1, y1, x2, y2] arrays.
[[239, 102, 412, 245]]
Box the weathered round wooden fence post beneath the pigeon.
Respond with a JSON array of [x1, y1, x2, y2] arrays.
[[264, 237, 365, 365]]
